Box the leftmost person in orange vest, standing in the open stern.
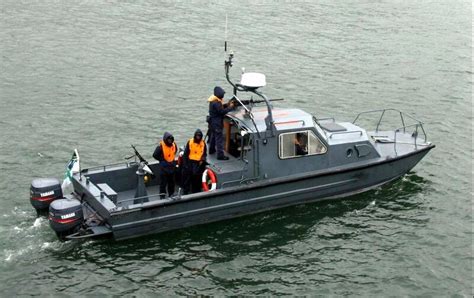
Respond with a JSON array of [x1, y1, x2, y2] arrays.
[[153, 132, 178, 199]]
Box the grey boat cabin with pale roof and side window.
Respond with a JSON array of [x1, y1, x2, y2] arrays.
[[208, 100, 379, 188]]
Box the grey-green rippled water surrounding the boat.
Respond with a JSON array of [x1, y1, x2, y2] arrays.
[[0, 0, 473, 296]]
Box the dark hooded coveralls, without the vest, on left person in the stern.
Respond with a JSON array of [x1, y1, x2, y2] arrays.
[[153, 132, 178, 199]]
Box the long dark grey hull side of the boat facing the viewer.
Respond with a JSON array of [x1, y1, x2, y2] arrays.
[[108, 145, 434, 240]]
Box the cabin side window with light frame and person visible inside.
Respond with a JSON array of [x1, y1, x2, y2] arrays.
[[279, 130, 327, 159]]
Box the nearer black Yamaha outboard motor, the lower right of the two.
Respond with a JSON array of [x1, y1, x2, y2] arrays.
[[49, 198, 84, 240]]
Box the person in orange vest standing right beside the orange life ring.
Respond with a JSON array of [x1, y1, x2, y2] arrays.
[[183, 129, 207, 195]]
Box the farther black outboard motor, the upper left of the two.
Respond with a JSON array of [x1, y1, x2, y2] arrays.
[[30, 178, 63, 215]]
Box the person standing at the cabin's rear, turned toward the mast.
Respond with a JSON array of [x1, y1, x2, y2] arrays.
[[207, 86, 234, 160]]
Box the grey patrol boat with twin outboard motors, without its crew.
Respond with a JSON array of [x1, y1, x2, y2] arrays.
[[30, 54, 435, 240]]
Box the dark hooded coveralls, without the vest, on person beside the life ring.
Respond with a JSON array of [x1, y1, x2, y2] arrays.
[[183, 129, 207, 195]]
